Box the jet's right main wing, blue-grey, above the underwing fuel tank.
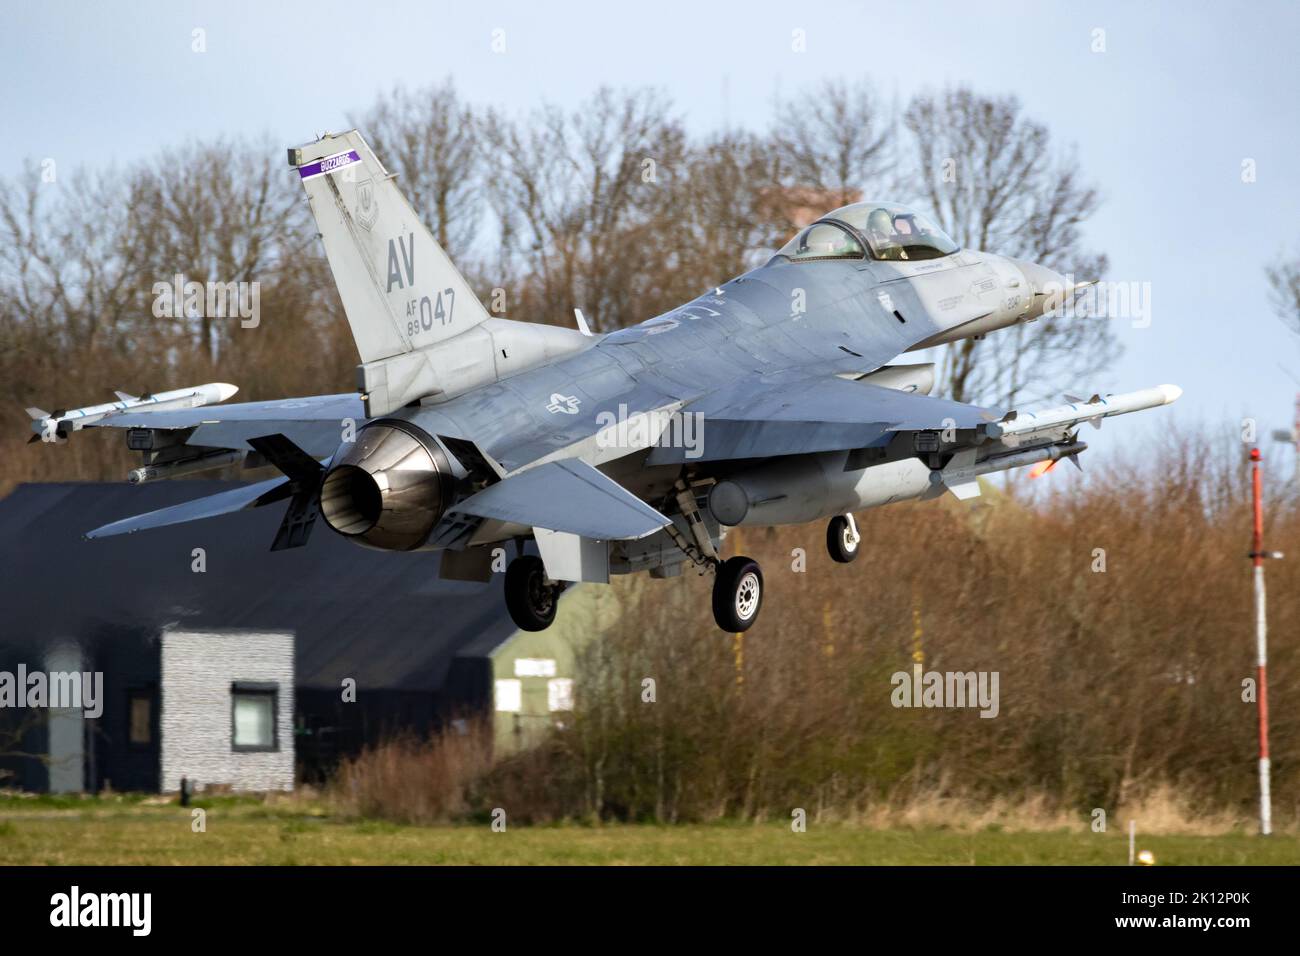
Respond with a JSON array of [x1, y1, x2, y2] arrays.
[[649, 376, 1001, 464]]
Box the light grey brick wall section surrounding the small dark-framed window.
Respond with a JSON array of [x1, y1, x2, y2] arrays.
[[161, 630, 294, 791]]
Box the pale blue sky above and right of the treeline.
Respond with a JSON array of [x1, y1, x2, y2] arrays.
[[0, 0, 1300, 465]]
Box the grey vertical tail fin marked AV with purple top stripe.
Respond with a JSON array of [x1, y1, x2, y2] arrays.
[[289, 130, 488, 363]]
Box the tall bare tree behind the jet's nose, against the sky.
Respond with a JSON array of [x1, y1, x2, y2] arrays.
[[904, 88, 1119, 405]]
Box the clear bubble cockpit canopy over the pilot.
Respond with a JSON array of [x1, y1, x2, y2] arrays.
[[777, 203, 957, 261]]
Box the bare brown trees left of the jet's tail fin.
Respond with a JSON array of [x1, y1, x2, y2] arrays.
[[0, 142, 356, 479]]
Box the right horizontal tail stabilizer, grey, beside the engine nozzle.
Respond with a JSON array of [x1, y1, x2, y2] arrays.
[[451, 458, 670, 541]]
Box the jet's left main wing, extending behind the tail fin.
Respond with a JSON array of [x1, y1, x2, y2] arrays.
[[87, 393, 365, 458]]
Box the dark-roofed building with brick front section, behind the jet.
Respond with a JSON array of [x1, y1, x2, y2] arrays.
[[0, 481, 603, 790]]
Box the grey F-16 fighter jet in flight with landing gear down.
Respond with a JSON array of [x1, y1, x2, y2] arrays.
[[30, 130, 1180, 632]]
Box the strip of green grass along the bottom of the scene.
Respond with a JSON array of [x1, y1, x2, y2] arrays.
[[0, 799, 1300, 866]]
